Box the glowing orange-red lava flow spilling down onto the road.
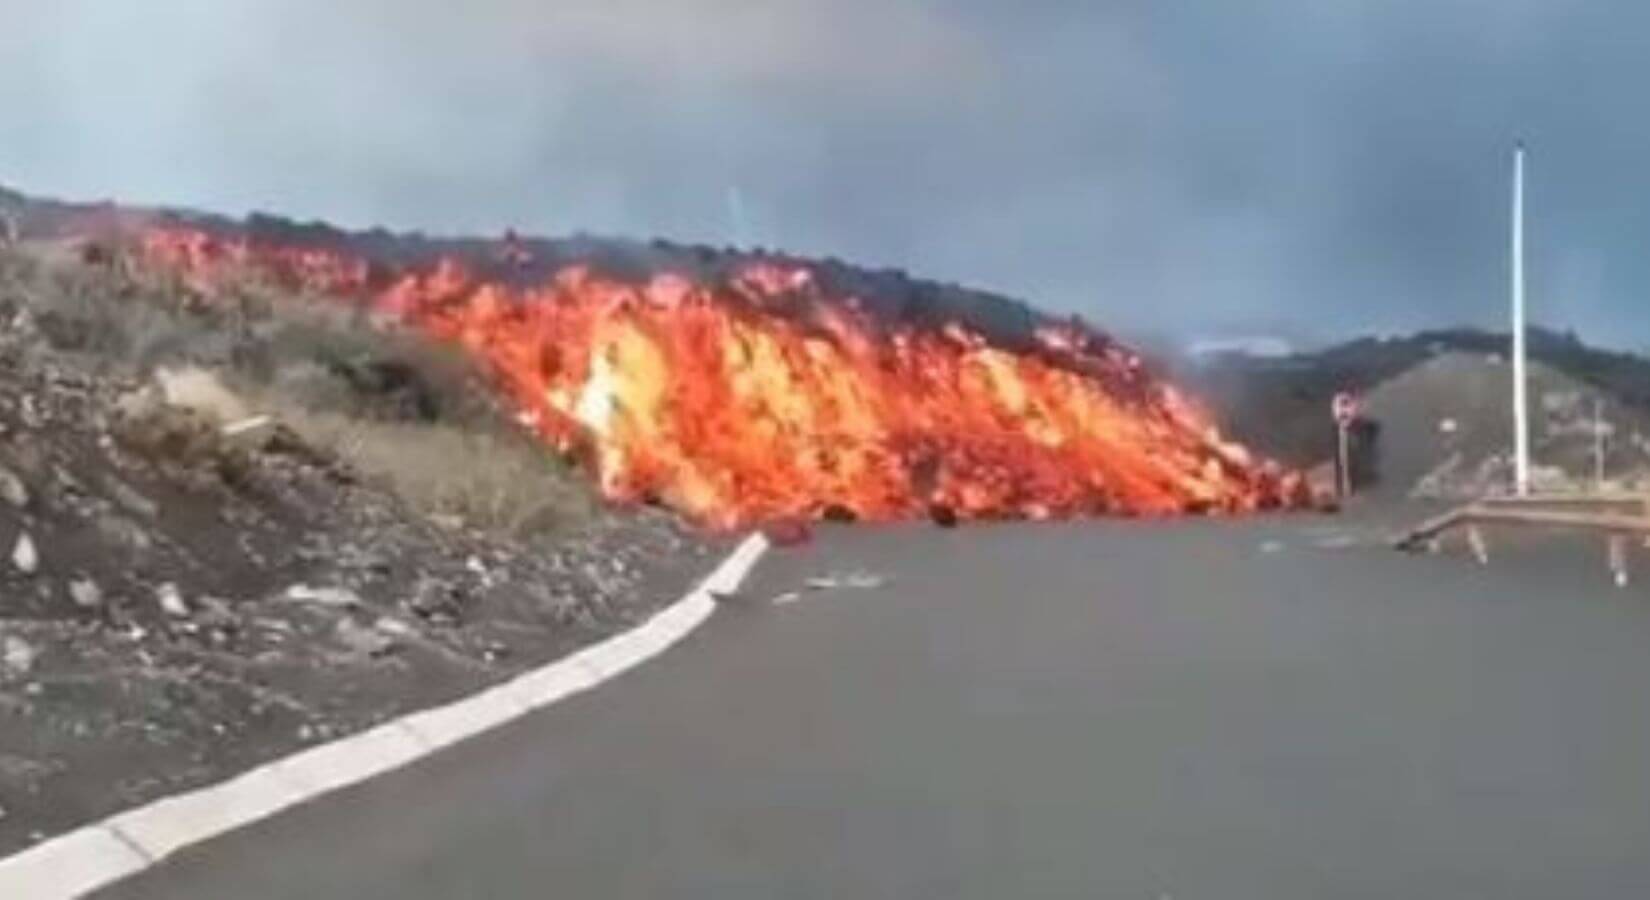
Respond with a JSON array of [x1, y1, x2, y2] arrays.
[[145, 228, 1305, 528]]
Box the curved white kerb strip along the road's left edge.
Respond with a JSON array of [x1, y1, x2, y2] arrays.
[[0, 532, 769, 900]]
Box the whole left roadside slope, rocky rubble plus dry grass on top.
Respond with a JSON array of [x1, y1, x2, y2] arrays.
[[0, 221, 721, 855]]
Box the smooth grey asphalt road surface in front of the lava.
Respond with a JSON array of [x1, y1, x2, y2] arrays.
[[106, 519, 1650, 900]]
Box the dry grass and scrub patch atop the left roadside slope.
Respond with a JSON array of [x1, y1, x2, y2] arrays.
[[0, 237, 597, 537]]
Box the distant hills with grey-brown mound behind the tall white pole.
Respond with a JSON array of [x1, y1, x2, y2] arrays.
[[1180, 329, 1650, 490]]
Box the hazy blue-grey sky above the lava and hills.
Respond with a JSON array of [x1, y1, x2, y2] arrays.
[[0, 0, 1650, 345]]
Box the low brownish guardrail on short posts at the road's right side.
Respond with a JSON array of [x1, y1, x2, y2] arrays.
[[1393, 494, 1650, 588]]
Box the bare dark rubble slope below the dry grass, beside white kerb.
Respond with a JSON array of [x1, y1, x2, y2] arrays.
[[0, 242, 718, 855]]
